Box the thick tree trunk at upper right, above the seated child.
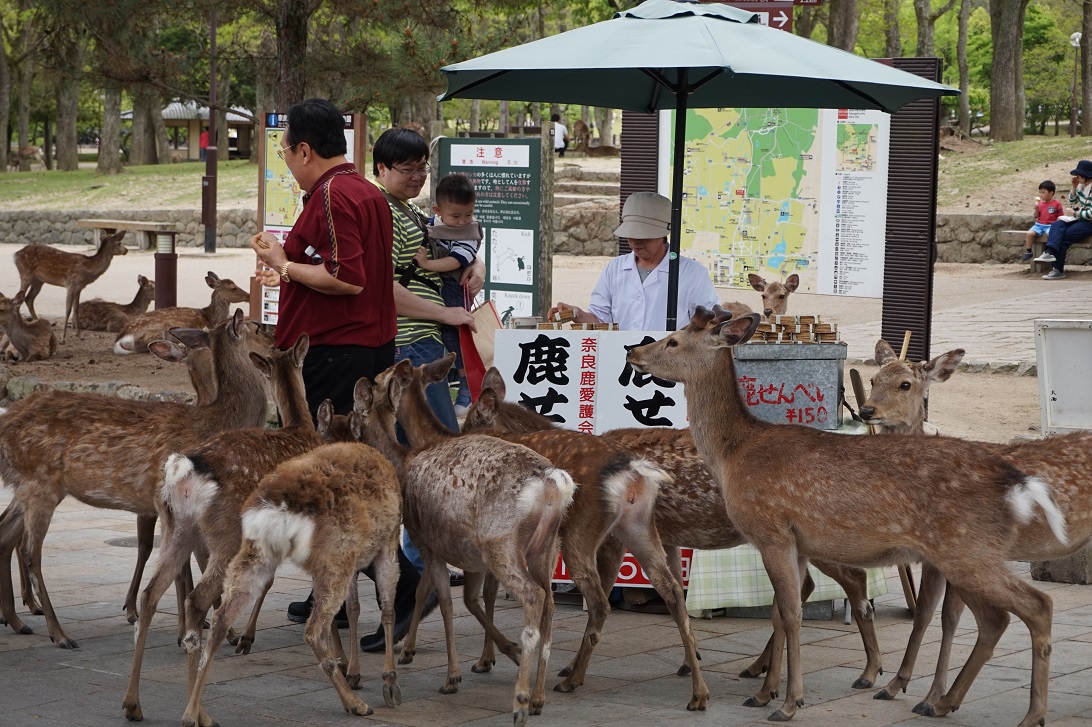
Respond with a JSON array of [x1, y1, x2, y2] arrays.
[[989, 0, 1028, 141]]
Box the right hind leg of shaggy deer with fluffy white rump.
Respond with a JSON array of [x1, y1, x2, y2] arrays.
[[307, 557, 372, 717]]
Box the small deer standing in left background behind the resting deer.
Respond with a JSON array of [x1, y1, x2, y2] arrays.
[[15, 230, 129, 343]]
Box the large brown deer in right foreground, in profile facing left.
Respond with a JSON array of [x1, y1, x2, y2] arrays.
[[627, 307, 1069, 727]]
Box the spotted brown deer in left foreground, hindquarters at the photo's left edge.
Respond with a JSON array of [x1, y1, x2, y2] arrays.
[[0, 311, 269, 648]]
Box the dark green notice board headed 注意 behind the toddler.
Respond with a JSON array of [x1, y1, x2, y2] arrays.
[[439, 139, 542, 323]]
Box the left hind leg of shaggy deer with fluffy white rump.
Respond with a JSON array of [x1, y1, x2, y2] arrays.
[[182, 541, 273, 727]]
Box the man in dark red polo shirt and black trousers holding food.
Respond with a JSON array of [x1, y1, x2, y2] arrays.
[[250, 98, 420, 622]]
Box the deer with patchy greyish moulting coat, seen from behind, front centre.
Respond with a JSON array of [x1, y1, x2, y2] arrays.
[[354, 357, 577, 727]]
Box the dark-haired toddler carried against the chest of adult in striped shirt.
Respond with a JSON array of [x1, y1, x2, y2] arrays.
[[414, 175, 482, 416]]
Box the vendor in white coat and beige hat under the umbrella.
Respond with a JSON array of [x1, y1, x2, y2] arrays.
[[548, 192, 720, 331]]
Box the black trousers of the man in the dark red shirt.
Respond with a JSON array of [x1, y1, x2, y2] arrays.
[[304, 341, 420, 621]]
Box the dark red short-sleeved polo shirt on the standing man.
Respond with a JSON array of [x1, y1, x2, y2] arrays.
[[276, 164, 397, 348]]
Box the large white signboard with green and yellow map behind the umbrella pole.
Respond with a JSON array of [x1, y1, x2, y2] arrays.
[[658, 108, 890, 298]]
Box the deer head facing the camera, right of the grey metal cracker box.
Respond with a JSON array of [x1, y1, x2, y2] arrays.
[[859, 338, 965, 434]]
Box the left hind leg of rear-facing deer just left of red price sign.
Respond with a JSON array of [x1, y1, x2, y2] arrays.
[[554, 537, 626, 692]]
